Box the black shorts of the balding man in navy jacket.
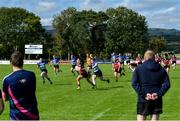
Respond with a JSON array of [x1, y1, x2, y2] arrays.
[[137, 101, 162, 116]]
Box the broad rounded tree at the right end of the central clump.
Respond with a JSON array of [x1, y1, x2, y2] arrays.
[[105, 7, 148, 53]]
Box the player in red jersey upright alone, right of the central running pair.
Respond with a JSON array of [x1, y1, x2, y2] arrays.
[[113, 59, 121, 82]]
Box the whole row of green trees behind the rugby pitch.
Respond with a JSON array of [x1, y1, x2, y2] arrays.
[[0, 7, 166, 58]]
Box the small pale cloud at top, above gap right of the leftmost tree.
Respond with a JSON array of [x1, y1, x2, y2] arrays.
[[36, 1, 56, 12]]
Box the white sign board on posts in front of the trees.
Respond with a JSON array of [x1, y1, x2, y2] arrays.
[[25, 45, 43, 54]]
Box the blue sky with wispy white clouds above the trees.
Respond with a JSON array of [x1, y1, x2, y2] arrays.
[[0, 0, 180, 30]]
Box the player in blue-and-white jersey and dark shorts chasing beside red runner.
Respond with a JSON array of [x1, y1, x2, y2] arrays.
[[91, 59, 110, 85]]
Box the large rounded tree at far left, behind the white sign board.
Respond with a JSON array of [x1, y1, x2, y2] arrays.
[[0, 7, 47, 57]]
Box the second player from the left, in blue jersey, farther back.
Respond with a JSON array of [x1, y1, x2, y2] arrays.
[[51, 55, 62, 75]]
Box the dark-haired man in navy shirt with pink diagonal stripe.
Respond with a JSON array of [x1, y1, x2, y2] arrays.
[[2, 51, 39, 120]]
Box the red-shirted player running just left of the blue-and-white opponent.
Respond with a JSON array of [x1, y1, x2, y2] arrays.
[[76, 59, 95, 90]]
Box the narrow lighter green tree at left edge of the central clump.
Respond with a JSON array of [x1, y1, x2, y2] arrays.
[[53, 7, 77, 59]]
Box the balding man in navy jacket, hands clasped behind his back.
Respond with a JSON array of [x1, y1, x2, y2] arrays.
[[132, 50, 170, 121]]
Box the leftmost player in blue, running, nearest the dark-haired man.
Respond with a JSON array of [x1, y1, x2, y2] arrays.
[[37, 58, 53, 84]]
